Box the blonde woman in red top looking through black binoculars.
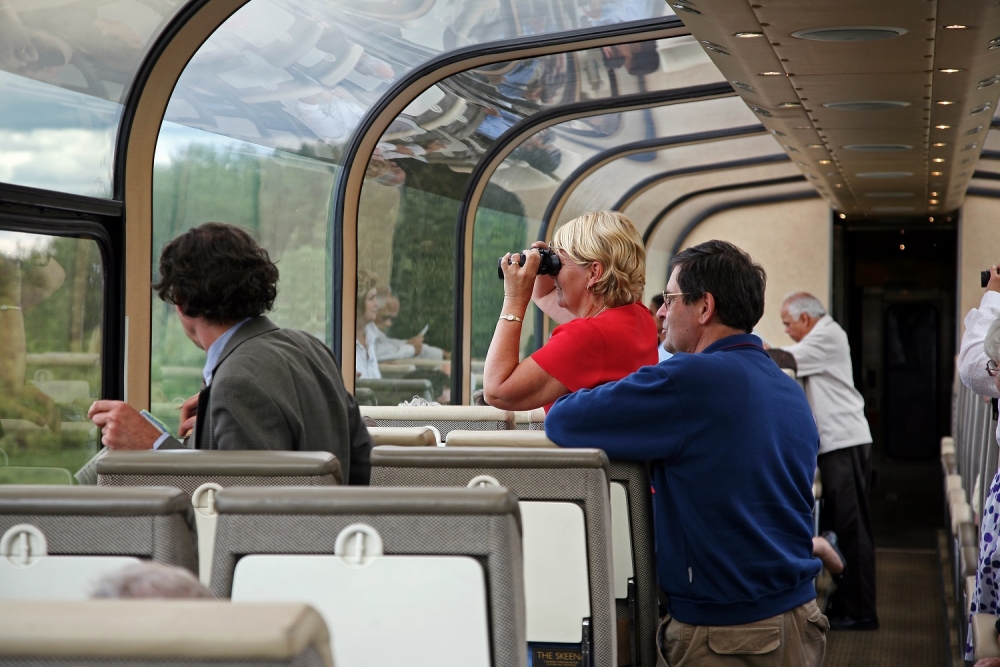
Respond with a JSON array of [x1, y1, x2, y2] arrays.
[[483, 211, 657, 410]]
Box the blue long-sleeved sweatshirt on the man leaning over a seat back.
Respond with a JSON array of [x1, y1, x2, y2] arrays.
[[545, 334, 821, 625]]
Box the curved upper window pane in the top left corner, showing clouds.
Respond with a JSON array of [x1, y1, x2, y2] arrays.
[[0, 0, 184, 198]]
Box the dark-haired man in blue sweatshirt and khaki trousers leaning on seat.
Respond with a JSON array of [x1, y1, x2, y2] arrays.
[[545, 241, 829, 667]]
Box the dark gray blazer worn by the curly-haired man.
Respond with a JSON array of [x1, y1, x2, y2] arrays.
[[160, 315, 372, 484]]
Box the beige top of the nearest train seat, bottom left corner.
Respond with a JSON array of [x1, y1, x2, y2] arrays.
[[0, 600, 333, 667]]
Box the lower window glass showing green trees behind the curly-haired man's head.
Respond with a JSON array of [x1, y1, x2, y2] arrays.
[[151, 123, 337, 436]]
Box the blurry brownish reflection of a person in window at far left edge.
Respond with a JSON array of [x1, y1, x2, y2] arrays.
[[0, 251, 66, 430]]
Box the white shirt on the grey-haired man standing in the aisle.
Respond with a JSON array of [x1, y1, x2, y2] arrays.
[[785, 315, 872, 454]]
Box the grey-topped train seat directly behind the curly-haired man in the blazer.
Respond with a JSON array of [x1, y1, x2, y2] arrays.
[[97, 449, 343, 584]]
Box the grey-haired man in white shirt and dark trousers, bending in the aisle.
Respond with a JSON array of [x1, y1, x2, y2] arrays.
[[781, 292, 878, 630]]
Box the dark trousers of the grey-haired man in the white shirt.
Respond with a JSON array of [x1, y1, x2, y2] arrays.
[[817, 444, 876, 618]]
